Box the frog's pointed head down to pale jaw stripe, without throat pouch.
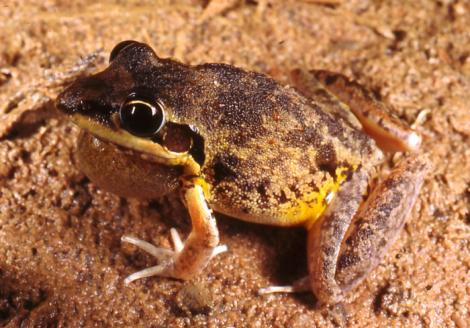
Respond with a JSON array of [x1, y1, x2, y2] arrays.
[[56, 41, 202, 174]]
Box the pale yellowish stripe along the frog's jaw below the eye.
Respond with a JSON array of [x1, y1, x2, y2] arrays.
[[71, 114, 201, 175]]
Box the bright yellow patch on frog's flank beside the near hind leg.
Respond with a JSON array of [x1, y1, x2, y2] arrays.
[[281, 167, 356, 230]]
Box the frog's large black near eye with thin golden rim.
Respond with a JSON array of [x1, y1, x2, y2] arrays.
[[119, 100, 165, 137]]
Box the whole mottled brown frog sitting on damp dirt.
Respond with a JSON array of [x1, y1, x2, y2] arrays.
[[56, 40, 429, 304]]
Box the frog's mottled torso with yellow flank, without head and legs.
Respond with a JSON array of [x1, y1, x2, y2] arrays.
[[155, 60, 382, 225]]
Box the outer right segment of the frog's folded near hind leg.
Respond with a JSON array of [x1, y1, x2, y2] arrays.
[[336, 156, 428, 291]]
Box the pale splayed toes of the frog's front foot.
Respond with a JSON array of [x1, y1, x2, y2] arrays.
[[121, 228, 228, 285]]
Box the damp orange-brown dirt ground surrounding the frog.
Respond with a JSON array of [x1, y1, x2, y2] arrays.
[[0, 0, 470, 328]]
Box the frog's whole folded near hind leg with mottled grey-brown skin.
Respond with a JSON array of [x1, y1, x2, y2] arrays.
[[307, 156, 427, 304]]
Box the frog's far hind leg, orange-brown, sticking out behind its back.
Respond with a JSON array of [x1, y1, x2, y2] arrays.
[[293, 70, 421, 152]]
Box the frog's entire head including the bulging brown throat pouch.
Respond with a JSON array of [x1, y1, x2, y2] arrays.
[[56, 41, 204, 198]]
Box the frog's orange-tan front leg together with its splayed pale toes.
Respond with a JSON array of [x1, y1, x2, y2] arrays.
[[122, 183, 227, 284]]
